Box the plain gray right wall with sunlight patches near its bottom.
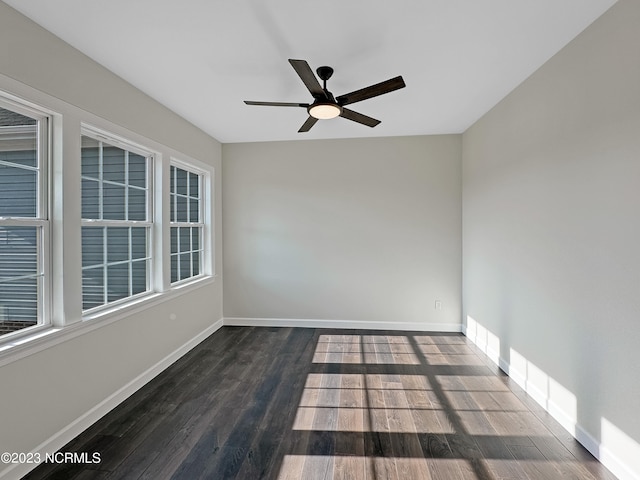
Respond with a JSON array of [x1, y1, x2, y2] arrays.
[[463, 0, 640, 478]]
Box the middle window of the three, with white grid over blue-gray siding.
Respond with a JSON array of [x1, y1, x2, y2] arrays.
[[81, 132, 152, 311]]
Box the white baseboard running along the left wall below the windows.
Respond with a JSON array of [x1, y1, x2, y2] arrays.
[[0, 319, 223, 479]]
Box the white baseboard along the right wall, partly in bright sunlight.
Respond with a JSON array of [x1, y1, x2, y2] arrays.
[[463, 326, 640, 480]]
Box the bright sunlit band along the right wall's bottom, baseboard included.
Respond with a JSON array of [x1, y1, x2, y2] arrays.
[[464, 316, 640, 480]]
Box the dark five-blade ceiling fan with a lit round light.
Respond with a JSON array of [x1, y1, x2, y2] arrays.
[[244, 59, 406, 132]]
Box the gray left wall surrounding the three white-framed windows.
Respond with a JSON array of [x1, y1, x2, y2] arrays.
[[0, 2, 222, 468]]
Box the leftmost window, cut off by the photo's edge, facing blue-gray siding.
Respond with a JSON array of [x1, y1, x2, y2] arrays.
[[0, 98, 49, 335]]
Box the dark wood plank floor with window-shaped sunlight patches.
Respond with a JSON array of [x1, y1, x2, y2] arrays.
[[25, 327, 615, 480]]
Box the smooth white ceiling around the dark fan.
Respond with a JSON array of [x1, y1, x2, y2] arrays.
[[4, 0, 616, 143]]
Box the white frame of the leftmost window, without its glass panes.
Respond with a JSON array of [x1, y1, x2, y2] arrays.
[[0, 92, 53, 343]]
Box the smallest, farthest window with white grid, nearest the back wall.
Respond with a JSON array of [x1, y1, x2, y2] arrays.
[[169, 165, 204, 284]]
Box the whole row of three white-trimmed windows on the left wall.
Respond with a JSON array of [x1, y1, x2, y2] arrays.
[[0, 88, 214, 352]]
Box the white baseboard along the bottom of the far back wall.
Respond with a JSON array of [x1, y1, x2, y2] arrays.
[[224, 317, 462, 332]]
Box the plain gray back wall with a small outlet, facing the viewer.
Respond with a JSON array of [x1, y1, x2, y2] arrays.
[[223, 135, 461, 330]]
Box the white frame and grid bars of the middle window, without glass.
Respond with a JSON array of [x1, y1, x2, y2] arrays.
[[79, 123, 158, 314]]
